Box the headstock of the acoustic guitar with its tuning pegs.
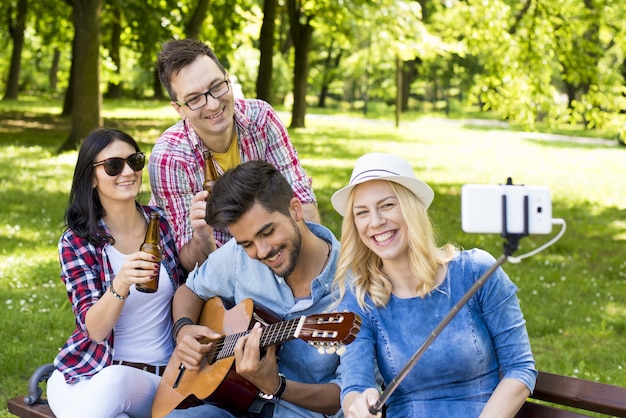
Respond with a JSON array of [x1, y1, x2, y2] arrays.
[[297, 312, 361, 355]]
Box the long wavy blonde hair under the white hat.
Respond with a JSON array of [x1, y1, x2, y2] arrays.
[[333, 181, 456, 309]]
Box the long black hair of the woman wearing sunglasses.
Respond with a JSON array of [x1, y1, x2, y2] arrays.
[[65, 128, 141, 245]]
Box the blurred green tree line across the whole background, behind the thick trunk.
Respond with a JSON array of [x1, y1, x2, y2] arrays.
[[0, 0, 626, 141]]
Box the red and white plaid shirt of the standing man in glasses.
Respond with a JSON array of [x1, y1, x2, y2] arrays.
[[148, 99, 317, 250]]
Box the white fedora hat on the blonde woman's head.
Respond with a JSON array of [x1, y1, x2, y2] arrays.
[[330, 152, 435, 216]]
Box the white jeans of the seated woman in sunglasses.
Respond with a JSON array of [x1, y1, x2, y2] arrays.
[[46, 365, 161, 418]]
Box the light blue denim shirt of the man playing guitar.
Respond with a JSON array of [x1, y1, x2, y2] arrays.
[[187, 223, 341, 418]]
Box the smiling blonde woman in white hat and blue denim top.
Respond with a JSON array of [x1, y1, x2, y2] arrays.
[[332, 153, 537, 418]]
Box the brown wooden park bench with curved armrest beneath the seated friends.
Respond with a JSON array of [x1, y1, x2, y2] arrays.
[[8, 364, 626, 418]]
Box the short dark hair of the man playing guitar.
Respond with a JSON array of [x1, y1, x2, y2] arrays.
[[206, 160, 294, 232]]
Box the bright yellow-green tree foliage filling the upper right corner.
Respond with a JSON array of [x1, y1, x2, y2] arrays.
[[440, 0, 626, 129]]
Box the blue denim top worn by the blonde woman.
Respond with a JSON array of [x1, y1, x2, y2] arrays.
[[339, 249, 537, 418]]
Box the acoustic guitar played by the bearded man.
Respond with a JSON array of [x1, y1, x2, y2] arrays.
[[152, 297, 361, 418]]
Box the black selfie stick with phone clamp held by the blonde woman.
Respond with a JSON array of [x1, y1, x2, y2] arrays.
[[369, 178, 528, 415]]
